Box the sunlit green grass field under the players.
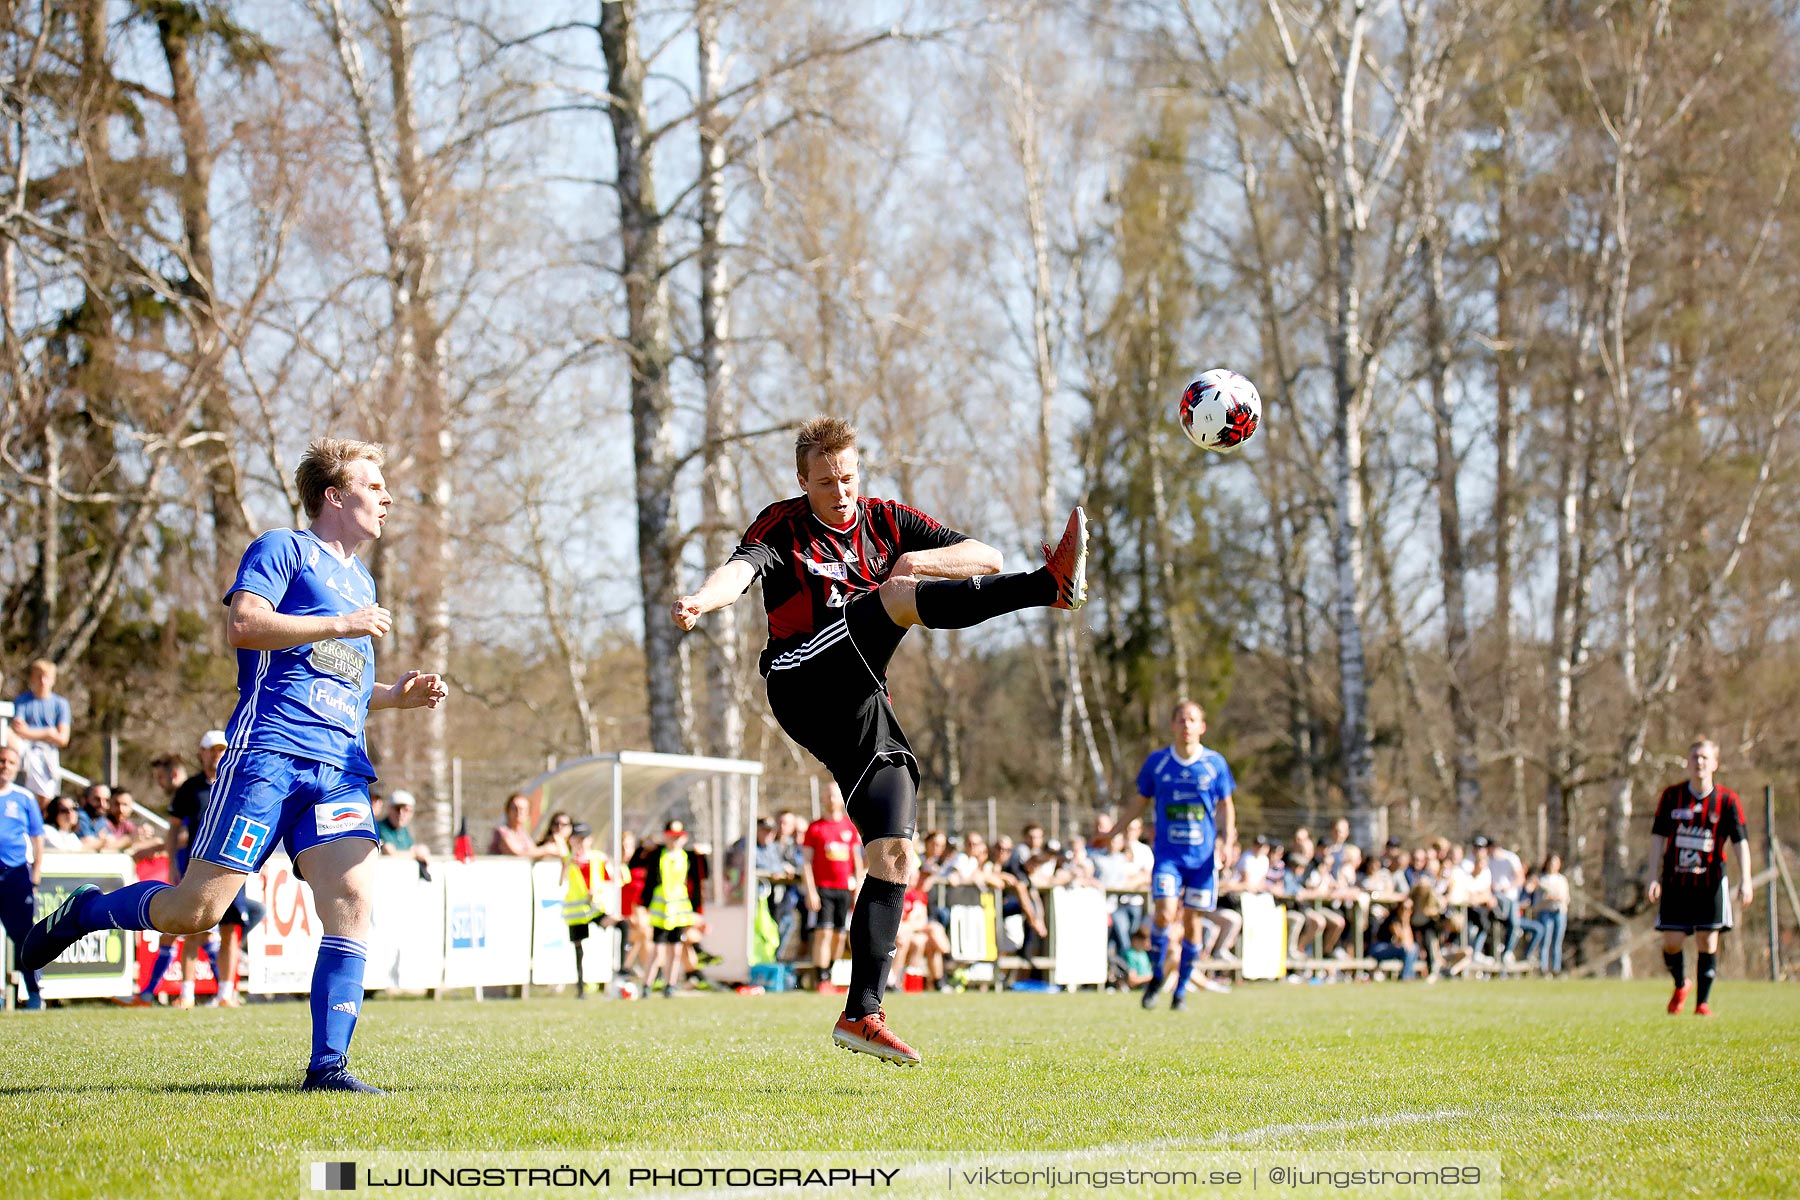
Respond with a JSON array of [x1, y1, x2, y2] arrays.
[[0, 981, 1800, 1198]]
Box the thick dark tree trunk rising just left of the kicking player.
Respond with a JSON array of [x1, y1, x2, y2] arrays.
[[598, 0, 686, 754]]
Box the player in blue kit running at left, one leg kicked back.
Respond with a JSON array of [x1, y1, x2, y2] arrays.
[[20, 437, 446, 1092]]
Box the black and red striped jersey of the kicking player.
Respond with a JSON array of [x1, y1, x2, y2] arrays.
[[731, 497, 968, 675]]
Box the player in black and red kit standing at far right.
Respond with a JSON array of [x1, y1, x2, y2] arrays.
[[1643, 738, 1751, 1016]]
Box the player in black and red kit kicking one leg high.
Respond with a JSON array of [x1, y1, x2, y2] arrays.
[[673, 417, 1087, 1063]]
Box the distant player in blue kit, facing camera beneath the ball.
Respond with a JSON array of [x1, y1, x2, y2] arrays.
[[1120, 700, 1237, 1011]]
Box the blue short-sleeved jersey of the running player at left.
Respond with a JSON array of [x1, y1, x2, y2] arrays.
[[225, 529, 374, 779]]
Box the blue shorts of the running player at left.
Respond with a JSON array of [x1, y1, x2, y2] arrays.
[[187, 750, 378, 874]]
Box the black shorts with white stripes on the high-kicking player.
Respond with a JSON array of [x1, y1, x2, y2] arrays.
[[767, 592, 918, 844]]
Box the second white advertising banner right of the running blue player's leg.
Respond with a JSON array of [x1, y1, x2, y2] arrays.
[[432, 858, 533, 988]]
